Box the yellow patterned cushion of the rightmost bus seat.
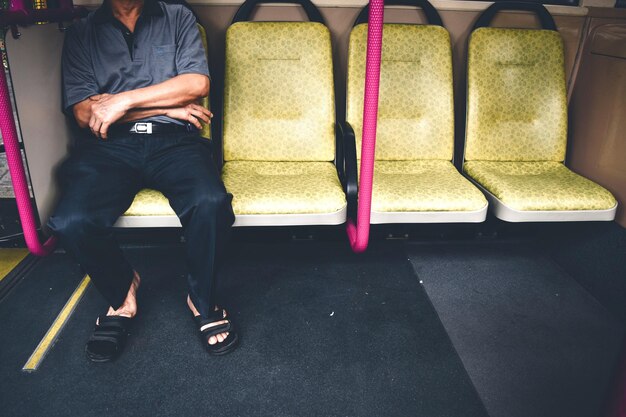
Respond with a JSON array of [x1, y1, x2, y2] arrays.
[[464, 161, 617, 211]]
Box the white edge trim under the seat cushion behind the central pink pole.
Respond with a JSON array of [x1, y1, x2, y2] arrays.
[[370, 204, 488, 224]]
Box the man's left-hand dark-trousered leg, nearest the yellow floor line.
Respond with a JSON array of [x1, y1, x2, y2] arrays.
[[48, 141, 141, 310]]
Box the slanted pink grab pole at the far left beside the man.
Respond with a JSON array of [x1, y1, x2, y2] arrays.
[[0, 57, 56, 256]]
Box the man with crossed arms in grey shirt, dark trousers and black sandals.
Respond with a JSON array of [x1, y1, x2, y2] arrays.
[[48, 0, 238, 362]]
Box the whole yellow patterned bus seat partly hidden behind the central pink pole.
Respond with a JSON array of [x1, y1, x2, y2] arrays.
[[346, 24, 487, 223]]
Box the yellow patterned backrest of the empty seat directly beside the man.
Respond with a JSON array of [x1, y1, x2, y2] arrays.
[[223, 22, 335, 161]]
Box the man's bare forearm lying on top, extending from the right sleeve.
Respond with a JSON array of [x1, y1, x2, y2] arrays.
[[113, 74, 209, 111]]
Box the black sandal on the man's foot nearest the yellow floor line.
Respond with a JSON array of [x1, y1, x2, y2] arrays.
[[85, 316, 133, 362]]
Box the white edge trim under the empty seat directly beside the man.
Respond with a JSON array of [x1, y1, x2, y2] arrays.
[[233, 207, 347, 227]]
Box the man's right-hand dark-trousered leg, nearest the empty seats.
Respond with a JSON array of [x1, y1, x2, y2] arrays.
[[147, 136, 235, 317]]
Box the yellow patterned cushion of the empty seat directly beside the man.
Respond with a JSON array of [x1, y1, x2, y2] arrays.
[[222, 161, 346, 215]]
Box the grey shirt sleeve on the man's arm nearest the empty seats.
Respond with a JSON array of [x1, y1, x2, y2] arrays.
[[176, 7, 209, 77]]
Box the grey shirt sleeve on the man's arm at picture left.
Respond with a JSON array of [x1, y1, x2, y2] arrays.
[[61, 25, 99, 115]]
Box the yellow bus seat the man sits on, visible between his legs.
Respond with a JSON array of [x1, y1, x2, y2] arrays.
[[115, 24, 211, 227]]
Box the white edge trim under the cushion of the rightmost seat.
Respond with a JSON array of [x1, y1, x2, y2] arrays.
[[467, 180, 617, 223]]
